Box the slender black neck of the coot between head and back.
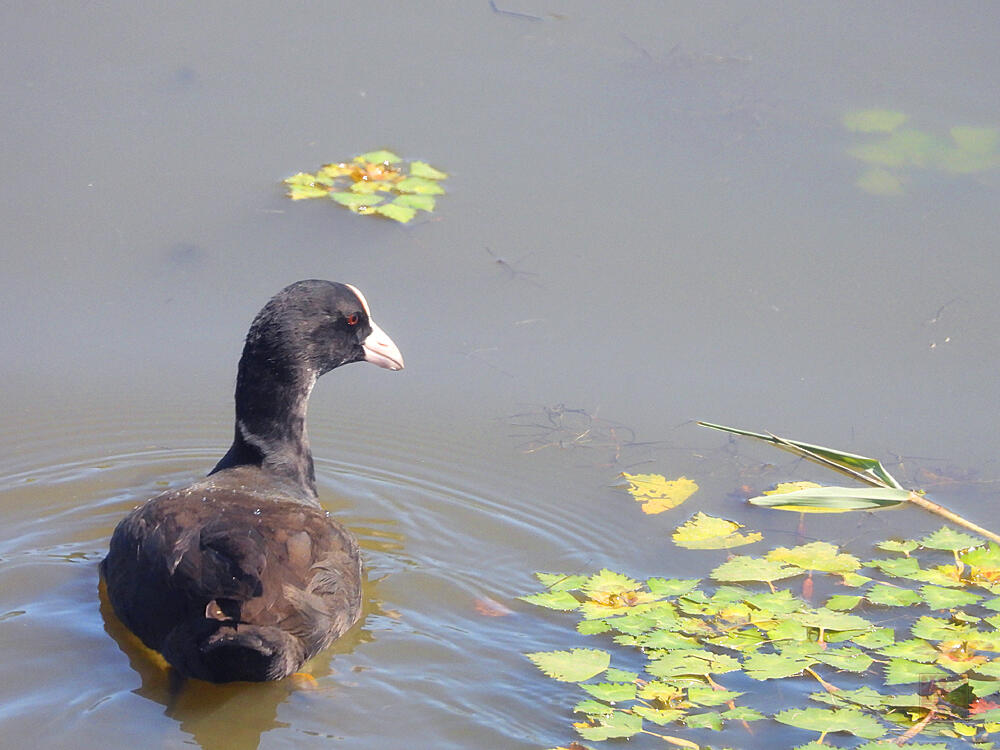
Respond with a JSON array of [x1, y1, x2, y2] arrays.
[[212, 347, 316, 497]]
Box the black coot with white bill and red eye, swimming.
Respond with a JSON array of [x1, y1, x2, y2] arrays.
[[101, 280, 403, 682]]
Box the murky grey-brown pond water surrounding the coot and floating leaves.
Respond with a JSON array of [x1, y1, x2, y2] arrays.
[[0, 0, 1000, 750]]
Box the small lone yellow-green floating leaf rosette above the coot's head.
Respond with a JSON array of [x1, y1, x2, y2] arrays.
[[284, 150, 448, 224]]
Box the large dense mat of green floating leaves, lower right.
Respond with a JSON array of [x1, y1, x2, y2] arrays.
[[522, 529, 1000, 748]]
